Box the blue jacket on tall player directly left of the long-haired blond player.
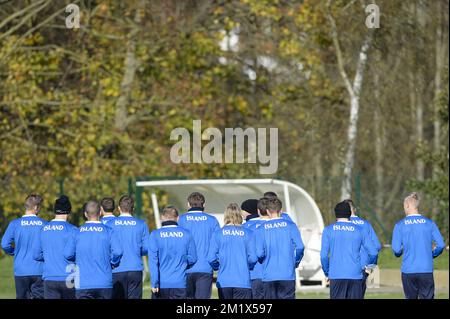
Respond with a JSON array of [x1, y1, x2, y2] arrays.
[[178, 208, 220, 273]]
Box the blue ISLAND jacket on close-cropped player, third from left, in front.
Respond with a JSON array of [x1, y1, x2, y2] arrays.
[[64, 221, 123, 290]]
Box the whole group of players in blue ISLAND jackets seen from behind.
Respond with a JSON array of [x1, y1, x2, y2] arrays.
[[1, 192, 445, 299]]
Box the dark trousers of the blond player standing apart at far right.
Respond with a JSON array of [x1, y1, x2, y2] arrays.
[[402, 273, 434, 299]]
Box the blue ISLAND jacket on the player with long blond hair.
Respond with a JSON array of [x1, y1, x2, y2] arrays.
[[208, 225, 257, 288]]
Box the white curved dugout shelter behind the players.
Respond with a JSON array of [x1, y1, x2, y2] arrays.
[[136, 179, 324, 283]]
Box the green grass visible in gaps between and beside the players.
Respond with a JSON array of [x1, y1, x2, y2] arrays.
[[0, 249, 449, 299]]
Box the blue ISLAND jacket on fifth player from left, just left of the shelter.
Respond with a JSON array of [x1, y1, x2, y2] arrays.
[[106, 214, 149, 273]]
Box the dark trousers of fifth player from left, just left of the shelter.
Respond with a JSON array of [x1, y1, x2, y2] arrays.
[[113, 271, 142, 299]]
